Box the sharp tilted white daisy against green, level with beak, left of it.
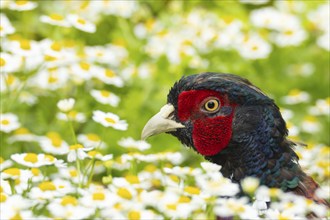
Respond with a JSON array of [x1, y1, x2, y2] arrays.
[[93, 110, 128, 131]]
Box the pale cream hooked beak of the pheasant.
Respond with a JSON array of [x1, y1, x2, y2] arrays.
[[141, 104, 184, 140]]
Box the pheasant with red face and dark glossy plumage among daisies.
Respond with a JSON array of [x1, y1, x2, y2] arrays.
[[142, 72, 329, 207]]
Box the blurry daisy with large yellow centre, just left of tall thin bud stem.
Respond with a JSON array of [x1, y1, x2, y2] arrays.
[[39, 132, 69, 155]]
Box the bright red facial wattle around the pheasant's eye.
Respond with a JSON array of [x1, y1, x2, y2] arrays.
[[178, 90, 235, 156]]
